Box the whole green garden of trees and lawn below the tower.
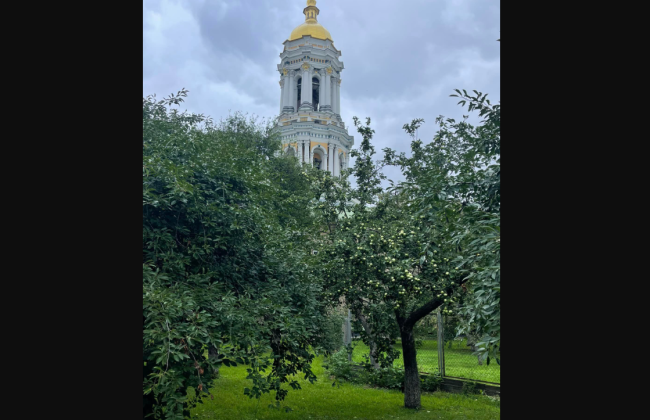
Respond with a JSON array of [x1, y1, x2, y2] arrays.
[[142, 90, 501, 420]]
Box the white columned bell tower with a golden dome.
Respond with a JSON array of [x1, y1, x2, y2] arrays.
[[278, 0, 354, 176]]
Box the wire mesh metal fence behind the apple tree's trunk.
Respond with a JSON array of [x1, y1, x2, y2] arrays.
[[346, 313, 501, 384]]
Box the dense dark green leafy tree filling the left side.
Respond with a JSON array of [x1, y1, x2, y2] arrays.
[[142, 91, 331, 419]]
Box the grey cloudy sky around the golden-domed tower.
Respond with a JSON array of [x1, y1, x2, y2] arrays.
[[143, 0, 501, 184]]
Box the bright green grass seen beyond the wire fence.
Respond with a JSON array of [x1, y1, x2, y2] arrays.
[[352, 340, 501, 384]]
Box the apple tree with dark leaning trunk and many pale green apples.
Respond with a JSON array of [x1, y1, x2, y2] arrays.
[[318, 118, 466, 408]]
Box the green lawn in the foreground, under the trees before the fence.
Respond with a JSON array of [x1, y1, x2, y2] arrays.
[[190, 357, 500, 420]]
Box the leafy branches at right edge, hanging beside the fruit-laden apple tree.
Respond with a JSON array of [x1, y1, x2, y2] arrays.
[[384, 89, 501, 364]]
